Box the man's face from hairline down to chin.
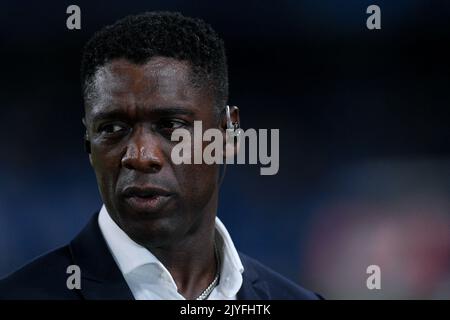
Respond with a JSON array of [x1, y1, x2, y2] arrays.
[[85, 57, 219, 247]]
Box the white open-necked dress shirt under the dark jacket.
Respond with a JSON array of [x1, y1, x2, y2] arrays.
[[98, 205, 244, 300]]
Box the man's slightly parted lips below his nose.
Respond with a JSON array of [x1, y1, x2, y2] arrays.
[[122, 186, 172, 213]]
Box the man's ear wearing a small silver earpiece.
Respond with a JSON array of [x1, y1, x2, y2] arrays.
[[221, 106, 241, 159]]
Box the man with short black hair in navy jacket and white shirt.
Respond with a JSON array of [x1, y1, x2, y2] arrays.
[[0, 12, 319, 300]]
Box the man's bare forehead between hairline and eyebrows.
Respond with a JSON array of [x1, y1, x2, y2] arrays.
[[86, 57, 213, 118]]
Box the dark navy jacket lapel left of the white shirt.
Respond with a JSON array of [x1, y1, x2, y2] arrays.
[[70, 213, 134, 300]]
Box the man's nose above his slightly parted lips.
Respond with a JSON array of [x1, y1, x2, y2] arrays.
[[122, 130, 163, 173]]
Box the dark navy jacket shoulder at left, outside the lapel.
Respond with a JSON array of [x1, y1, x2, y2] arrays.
[[0, 246, 77, 300]]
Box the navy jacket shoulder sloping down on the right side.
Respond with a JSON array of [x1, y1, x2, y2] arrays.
[[239, 253, 323, 300]]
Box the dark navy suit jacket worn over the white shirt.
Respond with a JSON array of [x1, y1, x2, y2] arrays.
[[0, 214, 321, 300]]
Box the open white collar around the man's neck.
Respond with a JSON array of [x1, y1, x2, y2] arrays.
[[98, 205, 244, 297]]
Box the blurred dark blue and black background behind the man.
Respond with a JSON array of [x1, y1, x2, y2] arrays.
[[0, 0, 450, 298]]
